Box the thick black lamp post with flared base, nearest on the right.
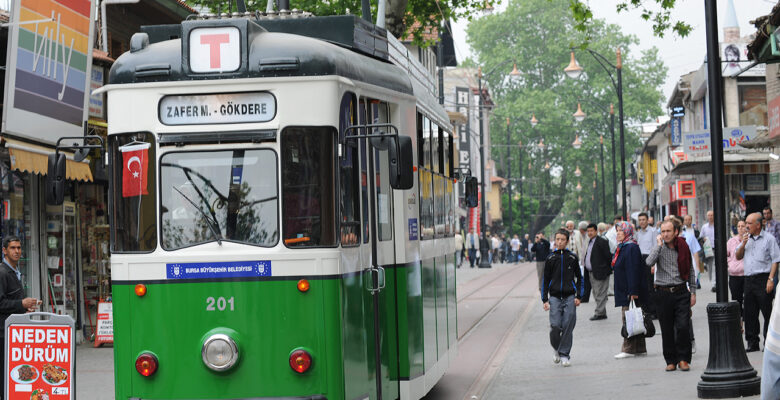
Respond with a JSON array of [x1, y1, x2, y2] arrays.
[[697, 0, 768, 399]]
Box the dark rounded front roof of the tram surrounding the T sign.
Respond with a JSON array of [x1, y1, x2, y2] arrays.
[[109, 18, 414, 95]]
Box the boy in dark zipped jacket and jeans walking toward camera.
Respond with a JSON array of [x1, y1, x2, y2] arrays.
[[542, 229, 582, 367]]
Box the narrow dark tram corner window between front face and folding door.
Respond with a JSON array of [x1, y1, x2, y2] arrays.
[[339, 93, 360, 246]]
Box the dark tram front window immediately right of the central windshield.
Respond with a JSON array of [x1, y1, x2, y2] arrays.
[[282, 127, 336, 247]]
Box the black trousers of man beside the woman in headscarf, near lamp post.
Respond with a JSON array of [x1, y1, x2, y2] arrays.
[[655, 290, 691, 364]]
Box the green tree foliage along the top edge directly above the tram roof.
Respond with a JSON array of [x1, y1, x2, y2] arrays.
[[185, 0, 495, 46]]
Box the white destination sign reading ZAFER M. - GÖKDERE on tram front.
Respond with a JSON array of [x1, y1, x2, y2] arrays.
[[159, 92, 276, 125]]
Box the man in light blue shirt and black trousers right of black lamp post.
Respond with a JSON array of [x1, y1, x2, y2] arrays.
[[736, 213, 780, 352]]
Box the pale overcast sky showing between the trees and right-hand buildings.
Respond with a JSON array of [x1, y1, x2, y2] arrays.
[[453, 0, 777, 108]]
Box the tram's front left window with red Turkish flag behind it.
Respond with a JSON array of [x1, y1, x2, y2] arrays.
[[109, 132, 157, 253]]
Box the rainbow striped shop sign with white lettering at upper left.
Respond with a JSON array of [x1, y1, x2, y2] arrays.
[[3, 0, 95, 144]]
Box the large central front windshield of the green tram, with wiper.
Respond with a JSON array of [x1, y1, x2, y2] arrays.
[[160, 149, 279, 250]]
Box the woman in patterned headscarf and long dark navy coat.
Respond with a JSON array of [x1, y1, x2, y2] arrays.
[[612, 221, 648, 359]]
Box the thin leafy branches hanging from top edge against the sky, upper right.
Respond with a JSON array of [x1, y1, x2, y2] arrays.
[[568, 0, 693, 37]]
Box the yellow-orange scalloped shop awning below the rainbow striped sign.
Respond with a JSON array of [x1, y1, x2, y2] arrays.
[[4, 138, 92, 182]]
